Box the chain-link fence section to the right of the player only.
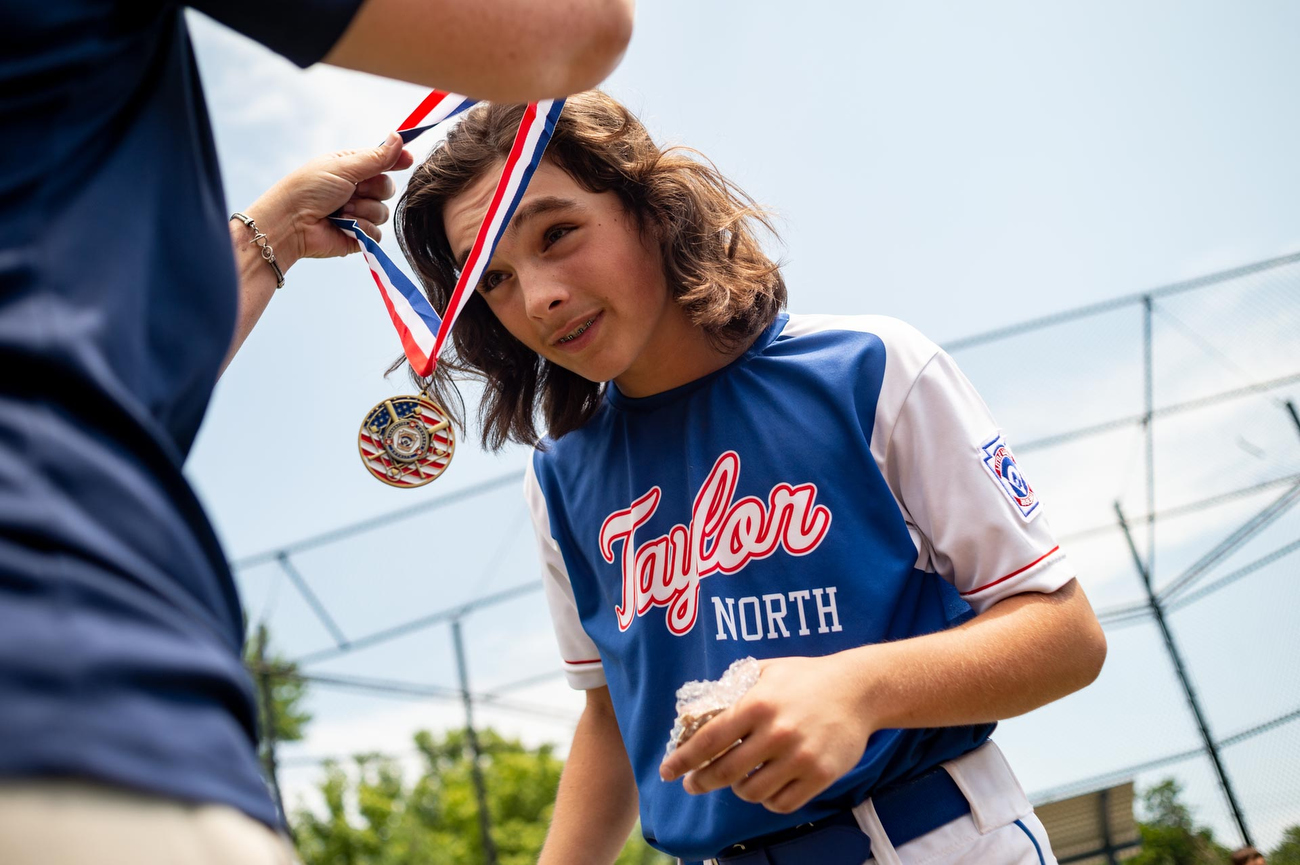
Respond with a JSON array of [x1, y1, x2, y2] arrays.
[[948, 255, 1300, 848]]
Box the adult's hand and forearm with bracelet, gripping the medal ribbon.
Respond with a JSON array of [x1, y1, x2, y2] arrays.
[[221, 133, 411, 372]]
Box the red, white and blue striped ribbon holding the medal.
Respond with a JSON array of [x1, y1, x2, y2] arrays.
[[330, 91, 564, 376]]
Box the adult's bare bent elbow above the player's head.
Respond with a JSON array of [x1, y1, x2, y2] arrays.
[[325, 0, 634, 101]]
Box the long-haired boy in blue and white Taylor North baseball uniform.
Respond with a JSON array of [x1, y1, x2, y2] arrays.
[[398, 92, 1105, 865]]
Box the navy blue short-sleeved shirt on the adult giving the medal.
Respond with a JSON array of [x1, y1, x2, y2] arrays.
[[0, 0, 360, 825]]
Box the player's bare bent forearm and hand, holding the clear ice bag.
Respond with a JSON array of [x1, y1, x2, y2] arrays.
[[662, 580, 1106, 813]]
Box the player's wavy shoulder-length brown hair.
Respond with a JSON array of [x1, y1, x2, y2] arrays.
[[390, 91, 785, 450]]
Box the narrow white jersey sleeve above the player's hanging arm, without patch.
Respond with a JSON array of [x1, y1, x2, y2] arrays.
[[524, 459, 605, 691]]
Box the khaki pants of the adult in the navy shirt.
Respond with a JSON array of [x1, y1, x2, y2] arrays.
[[0, 780, 296, 865]]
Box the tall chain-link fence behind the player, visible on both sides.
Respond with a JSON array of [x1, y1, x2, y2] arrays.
[[241, 254, 1300, 848]]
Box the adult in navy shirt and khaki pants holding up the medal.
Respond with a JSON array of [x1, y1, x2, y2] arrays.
[[0, 0, 632, 865]]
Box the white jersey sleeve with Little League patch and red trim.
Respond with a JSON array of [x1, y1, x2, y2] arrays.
[[871, 319, 1075, 613]]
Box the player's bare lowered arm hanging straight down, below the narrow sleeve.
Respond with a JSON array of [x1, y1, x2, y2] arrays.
[[538, 688, 637, 865]]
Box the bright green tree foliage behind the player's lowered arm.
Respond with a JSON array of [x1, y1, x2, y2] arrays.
[[295, 730, 672, 865]]
